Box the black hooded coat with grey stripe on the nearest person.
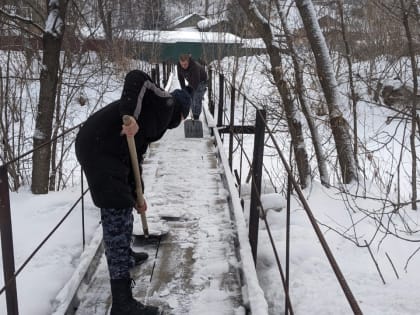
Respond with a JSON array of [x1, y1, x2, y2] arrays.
[[76, 70, 180, 209]]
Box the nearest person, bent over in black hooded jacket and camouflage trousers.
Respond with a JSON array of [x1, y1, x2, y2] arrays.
[[75, 70, 191, 315]]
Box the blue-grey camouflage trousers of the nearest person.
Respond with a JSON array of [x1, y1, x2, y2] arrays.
[[101, 208, 134, 279]]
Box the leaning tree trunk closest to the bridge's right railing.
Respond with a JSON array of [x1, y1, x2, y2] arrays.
[[238, 0, 310, 188]]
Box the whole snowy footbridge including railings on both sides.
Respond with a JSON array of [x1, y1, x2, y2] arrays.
[[0, 70, 361, 315]]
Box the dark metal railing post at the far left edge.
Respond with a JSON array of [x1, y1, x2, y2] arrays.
[[0, 165, 19, 315]]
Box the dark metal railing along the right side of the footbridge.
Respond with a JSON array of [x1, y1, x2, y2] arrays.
[[208, 69, 362, 314]]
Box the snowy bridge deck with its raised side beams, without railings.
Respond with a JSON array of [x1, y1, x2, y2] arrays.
[[49, 80, 267, 315]]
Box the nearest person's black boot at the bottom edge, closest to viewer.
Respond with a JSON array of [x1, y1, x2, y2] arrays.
[[111, 279, 160, 315]]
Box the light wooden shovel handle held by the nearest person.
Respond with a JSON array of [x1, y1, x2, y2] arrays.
[[123, 115, 149, 238]]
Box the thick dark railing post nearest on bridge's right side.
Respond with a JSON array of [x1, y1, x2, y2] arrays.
[[248, 109, 265, 265]]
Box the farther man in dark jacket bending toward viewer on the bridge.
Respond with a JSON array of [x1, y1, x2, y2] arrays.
[[177, 54, 207, 120]]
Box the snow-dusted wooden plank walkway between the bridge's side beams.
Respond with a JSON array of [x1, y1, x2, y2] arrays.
[[73, 119, 245, 315]]
